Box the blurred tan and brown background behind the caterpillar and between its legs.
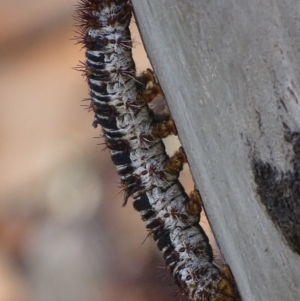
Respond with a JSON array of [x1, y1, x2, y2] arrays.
[[0, 0, 216, 301]]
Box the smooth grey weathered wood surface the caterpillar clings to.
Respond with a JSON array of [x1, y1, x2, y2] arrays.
[[132, 0, 300, 301]]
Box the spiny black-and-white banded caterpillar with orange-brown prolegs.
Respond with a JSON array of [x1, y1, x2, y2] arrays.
[[77, 0, 238, 301]]
